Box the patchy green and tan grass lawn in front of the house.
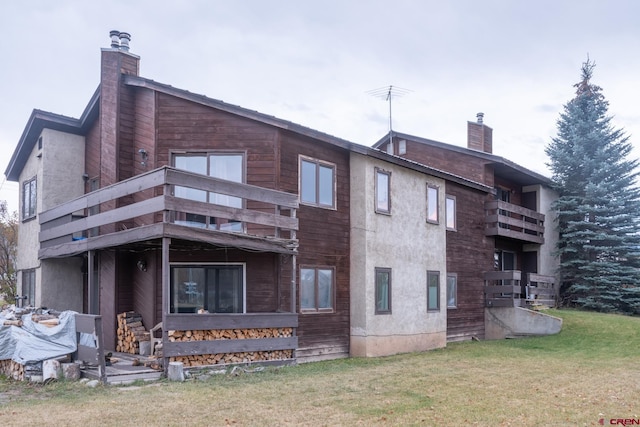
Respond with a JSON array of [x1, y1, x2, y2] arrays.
[[0, 310, 640, 426]]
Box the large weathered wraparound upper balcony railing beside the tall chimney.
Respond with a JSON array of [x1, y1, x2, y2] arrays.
[[38, 166, 298, 259]]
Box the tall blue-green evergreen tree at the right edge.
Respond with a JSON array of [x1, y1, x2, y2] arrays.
[[545, 59, 640, 314]]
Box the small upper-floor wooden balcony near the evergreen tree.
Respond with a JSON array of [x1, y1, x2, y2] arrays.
[[484, 200, 544, 244]]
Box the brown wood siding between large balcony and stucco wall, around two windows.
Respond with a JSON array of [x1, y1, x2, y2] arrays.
[[280, 131, 350, 349]]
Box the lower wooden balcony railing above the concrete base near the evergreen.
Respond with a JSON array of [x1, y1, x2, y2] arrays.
[[484, 270, 557, 307]]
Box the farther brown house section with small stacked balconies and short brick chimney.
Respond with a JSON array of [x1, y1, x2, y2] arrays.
[[374, 113, 559, 341]]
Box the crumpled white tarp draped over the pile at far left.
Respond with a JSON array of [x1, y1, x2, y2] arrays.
[[0, 311, 77, 365]]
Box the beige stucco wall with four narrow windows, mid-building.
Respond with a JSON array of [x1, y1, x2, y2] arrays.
[[350, 153, 446, 356]]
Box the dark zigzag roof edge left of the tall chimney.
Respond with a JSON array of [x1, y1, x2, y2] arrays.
[[4, 87, 100, 182]]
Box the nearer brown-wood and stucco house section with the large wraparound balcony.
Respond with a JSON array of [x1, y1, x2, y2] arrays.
[[6, 32, 504, 363]]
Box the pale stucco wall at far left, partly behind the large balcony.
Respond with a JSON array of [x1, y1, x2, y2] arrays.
[[17, 129, 85, 311]]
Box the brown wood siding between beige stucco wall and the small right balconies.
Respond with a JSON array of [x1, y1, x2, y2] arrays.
[[446, 182, 494, 340]]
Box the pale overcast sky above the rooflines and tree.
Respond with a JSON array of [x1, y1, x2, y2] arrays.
[[0, 0, 640, 214]]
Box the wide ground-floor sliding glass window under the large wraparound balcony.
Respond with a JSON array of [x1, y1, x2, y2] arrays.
[[169, 264, 245, 313]]
